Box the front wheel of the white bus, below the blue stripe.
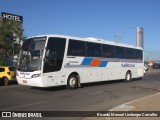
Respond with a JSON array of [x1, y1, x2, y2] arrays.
[[67, 74, 78, 90]]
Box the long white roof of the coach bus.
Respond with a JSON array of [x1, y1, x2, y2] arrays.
[[29, 34, 143, 50]]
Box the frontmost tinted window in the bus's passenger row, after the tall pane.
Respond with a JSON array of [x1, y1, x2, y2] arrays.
[[67, 40, 85, 56]]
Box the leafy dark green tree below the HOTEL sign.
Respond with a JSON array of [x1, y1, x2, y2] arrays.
[[0, 20, 23, 65]]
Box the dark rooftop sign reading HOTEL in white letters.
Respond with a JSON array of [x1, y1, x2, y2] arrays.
[[1, 12, 23, 23]]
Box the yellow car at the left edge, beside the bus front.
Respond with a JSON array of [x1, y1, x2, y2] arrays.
[[0, 66, 16, 85]]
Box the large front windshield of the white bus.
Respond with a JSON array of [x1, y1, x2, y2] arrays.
[[17, 37, 46, 72]]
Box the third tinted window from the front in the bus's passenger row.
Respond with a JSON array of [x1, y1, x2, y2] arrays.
[[102, 44, 114, 58]]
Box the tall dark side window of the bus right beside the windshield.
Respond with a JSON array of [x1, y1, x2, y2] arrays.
[[43, 37, 66, 73]]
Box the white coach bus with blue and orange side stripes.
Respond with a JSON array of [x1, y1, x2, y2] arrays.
[[16, 35, 144, 89]]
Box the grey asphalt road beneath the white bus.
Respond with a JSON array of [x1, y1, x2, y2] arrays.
[[0, 69, 160, 119]]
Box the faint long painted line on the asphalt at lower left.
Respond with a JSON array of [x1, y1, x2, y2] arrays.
[[0, 101, 47, 110]]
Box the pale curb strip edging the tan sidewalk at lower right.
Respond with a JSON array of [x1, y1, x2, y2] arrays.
[[109, 93, 160, 111]]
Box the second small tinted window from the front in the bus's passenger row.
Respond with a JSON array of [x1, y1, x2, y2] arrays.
[[86, 42, 101, 57]]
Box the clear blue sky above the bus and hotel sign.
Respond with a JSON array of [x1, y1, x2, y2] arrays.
[[0, 0, 160, 60]]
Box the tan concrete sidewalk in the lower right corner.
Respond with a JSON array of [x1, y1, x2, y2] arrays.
[[83, 93, 160, 120]]
